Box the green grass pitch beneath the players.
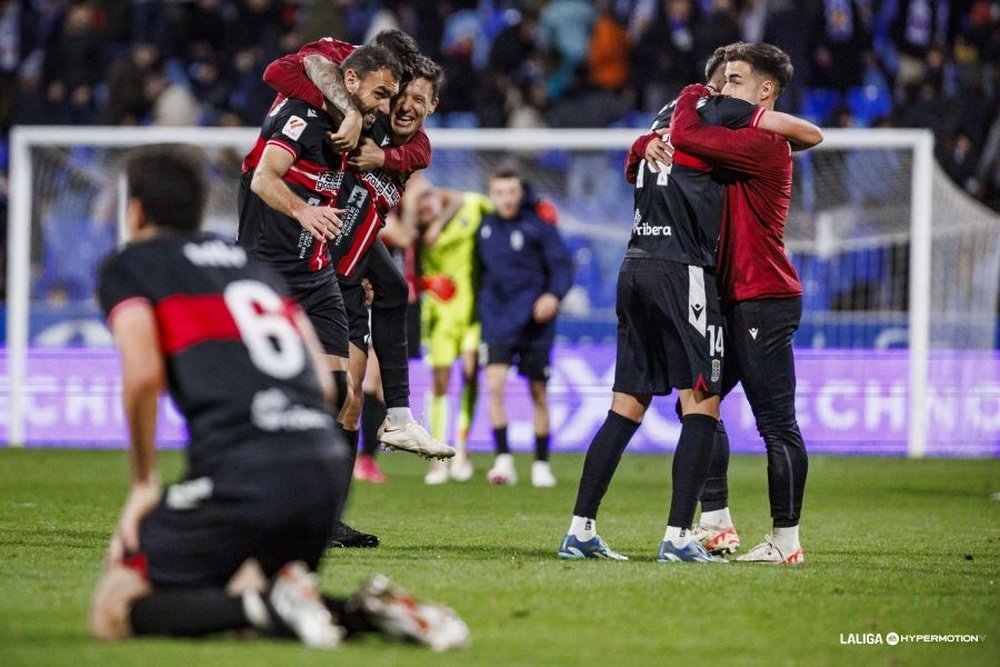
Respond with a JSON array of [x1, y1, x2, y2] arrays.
[[0, 449, 1000, 667]]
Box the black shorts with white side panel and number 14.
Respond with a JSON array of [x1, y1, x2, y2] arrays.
[[614, 259, 725, 396]]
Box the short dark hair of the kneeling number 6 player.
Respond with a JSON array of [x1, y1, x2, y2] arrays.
[[125, 144, 208, 233]]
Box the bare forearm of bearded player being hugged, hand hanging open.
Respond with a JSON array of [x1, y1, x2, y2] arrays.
[[250, 143, 343, 242]]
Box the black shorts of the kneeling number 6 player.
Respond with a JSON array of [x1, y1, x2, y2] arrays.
[[139, 459, 342, 587]]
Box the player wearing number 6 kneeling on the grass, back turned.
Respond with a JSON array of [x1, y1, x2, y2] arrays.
[[90, 146, 468, 649]]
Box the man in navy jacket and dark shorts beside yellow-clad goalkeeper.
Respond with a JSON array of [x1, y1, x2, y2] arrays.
[[477, 167, 573, 487]]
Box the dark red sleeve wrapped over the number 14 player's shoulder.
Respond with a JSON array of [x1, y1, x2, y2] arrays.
[[670, 84, 790, 176]]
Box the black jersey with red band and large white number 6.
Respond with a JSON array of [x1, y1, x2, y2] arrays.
[[98, 235, 333, 476]]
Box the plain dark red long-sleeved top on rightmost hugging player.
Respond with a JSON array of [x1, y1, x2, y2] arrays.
[[670, 85, 802, 301]]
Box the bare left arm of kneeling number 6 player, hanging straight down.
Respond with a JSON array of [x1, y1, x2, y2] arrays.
[[109, 298, 166, 561]]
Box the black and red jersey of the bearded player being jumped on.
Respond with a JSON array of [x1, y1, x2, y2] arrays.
[[237, 99, 346, 285]]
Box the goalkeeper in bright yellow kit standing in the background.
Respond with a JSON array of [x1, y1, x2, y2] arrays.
[[412, 178, 493, 484]]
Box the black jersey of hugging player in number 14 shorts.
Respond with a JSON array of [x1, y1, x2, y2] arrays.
[[625, 97, 758, 268]]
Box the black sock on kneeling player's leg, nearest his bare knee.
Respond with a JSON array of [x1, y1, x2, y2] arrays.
[[129, 588, 252, 637]]
